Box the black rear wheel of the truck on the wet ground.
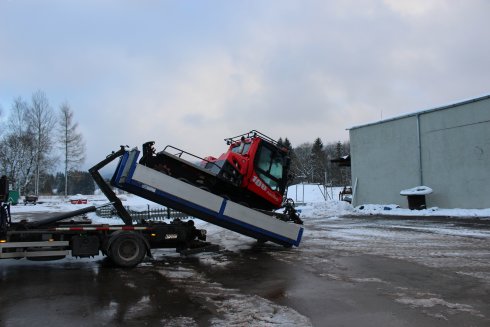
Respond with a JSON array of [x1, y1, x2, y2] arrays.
[[109, 234, 146, 267]]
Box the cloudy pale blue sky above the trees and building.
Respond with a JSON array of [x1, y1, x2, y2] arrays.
[[0, 0, 490, 172]]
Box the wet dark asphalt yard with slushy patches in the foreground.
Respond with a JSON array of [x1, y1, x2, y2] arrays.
[[0, 213, 490, 326]]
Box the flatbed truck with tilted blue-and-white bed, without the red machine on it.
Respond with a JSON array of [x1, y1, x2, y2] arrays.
[[0, 146, 303, 267]]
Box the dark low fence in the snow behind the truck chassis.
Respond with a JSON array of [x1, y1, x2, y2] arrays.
[[95, 205, 194, 222]]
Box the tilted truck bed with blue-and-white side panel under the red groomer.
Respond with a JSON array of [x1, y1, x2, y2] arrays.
[[111, 149, 303, 247]]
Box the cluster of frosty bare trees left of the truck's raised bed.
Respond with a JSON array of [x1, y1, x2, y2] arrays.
[[0, 90, 87, 196]]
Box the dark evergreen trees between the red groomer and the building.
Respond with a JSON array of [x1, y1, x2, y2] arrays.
[[278, 137, 351, 186]]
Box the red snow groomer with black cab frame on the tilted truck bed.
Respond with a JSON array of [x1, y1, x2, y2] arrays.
[[139, 130, 300, 223]]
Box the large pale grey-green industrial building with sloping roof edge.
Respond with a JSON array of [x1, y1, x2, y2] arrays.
[[349, 95, 490, 209]]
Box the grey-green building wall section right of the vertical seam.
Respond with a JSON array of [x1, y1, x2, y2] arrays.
[[420, 99, 490, 208]]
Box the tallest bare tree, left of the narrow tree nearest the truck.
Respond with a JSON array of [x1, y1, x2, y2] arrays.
[[28, 91, 56, 195]]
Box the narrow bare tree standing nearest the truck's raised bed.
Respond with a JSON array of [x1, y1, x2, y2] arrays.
[[58, 102, 85, 196]]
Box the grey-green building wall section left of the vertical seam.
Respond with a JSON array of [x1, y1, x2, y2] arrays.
[[350, 117, 419, 206]]
